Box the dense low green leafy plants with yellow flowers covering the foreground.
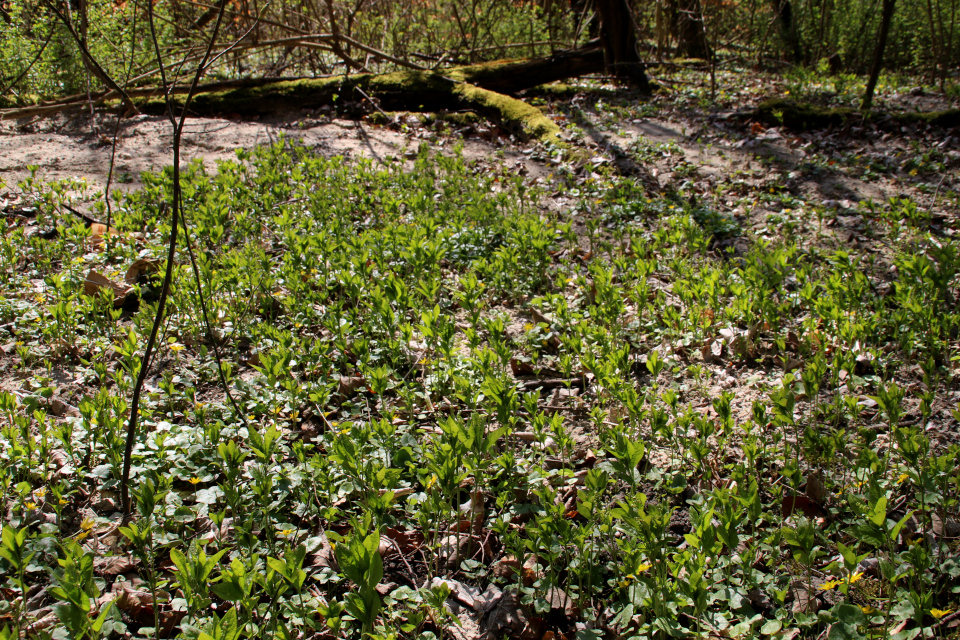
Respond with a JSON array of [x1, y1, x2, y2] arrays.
[[0, 142, 960, 640]]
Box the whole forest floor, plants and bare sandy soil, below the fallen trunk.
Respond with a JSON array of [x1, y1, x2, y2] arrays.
[[0, 66, 960, 640]]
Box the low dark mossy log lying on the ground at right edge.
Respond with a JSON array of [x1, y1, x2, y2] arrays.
[[754, 99, 960, 131]]
